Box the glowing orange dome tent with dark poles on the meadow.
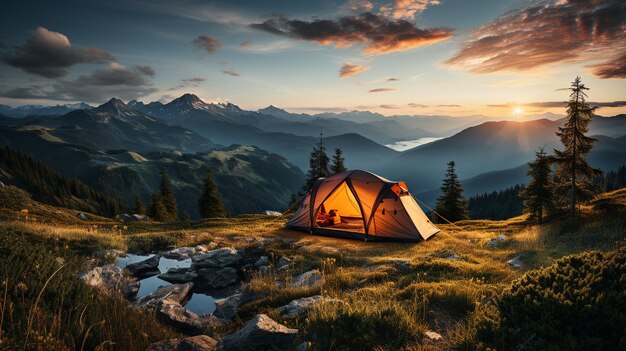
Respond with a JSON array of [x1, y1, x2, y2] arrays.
[[287, 170, 439, 241]]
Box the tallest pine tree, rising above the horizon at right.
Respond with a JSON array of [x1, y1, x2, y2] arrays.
[[554, 77, 601, 219]]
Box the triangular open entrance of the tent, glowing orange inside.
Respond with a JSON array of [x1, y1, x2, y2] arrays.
[[315, 181, 365, 233]]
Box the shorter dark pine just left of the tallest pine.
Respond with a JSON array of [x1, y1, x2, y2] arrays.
[[520, 148, 555, 224]]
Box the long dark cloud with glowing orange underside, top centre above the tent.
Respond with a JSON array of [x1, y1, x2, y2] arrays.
[[251, 12, 452, 55]]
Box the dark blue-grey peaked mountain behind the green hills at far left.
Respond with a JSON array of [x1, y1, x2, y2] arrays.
[[0, 98, 216, 152]]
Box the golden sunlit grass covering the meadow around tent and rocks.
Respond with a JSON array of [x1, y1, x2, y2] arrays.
[[0, 190, 626, 350]]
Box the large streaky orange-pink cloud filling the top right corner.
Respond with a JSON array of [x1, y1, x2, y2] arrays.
[[445, 0, 626, 78]]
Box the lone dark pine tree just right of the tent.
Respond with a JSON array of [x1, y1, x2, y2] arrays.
[[436, 161, 467, 222]]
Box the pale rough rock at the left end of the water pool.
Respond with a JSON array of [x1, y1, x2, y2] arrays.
[[81, 264, 139, 297]]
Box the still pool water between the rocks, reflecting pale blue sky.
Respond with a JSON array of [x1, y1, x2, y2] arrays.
[[115, 254, 215, 316]]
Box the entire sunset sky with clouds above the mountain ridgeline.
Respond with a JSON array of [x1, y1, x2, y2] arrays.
[[0, 0, 626, 118]]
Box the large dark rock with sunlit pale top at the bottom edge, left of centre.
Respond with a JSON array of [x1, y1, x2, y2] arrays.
[[218, 314, 298, 351]]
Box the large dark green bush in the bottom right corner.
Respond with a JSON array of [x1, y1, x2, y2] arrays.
[[477, 247, 626, 350]]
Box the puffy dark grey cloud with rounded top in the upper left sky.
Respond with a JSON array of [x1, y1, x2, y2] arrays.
[[4, 27, 113, 78]]
